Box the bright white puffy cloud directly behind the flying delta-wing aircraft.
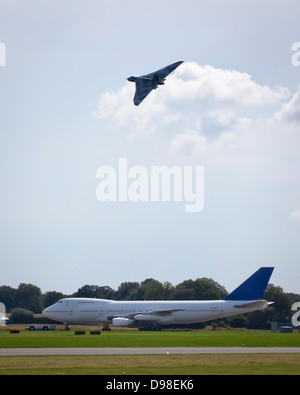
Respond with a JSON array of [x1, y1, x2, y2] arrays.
[[94, 62, 290, 139]]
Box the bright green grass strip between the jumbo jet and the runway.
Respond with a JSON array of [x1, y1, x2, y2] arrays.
[[0, 331, 300, 348]]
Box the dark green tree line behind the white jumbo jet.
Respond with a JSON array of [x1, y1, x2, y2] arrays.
[[0, 278, 300, 329]]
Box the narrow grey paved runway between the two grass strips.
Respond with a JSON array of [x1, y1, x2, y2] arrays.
[[0, 347, 300, 357]]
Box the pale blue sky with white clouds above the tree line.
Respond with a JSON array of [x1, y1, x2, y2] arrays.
[[0, 0, 300, 294]]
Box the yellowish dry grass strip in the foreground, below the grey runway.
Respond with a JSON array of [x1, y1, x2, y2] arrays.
[[0, 354, 300, 376]]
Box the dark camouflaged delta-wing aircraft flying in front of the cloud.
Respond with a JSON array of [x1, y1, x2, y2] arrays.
[[127, 61, 183, 106]]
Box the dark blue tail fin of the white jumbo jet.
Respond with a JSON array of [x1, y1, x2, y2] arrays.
[[224, 267, 274, 300]]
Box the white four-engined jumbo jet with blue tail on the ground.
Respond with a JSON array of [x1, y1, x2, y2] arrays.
[[43, 267, 274, 330]]
